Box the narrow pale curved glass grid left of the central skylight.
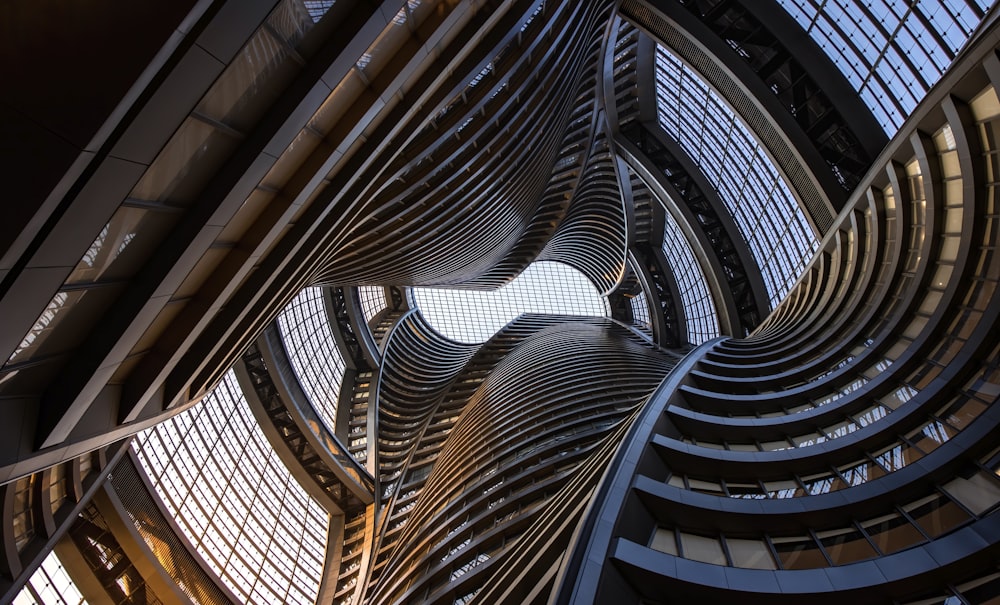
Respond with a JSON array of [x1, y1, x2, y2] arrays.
[[278, 288, 346, 433]]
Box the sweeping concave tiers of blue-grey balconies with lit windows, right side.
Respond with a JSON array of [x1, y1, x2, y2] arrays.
[[560, 21, 1000, 603]]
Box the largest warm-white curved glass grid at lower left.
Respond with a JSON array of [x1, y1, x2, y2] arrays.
[[133, 370, 329, 604]]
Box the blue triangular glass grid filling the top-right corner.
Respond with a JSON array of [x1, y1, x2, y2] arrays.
[[778, 0, 992, 137]]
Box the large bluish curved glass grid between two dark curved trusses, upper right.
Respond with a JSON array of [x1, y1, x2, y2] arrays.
[[656, 46, 819, 308]]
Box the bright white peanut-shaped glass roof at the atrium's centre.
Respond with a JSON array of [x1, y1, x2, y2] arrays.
[[409, 261, 611, 344]]
